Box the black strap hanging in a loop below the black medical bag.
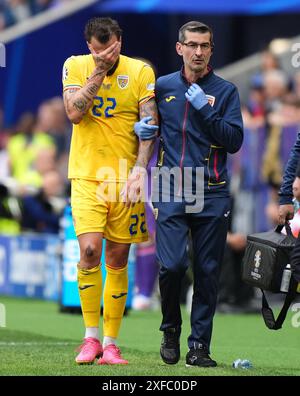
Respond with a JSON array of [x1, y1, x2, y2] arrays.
[[260, 277, 298, 330]]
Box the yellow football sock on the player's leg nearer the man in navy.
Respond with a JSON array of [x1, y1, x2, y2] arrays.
[[103, 265, 128, 338]]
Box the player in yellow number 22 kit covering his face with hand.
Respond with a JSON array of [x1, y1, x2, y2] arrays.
[[63, 18, 158, 364]]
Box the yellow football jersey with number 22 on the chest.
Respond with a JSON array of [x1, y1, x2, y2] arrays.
[[63, 55, 155, 181]]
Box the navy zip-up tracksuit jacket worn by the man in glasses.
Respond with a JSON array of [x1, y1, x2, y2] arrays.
[[156, 68, 244, 197]]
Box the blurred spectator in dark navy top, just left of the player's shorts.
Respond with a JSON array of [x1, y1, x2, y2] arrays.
[[22, 170, 66, 234]]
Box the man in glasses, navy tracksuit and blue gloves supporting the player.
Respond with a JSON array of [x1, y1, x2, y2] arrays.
[[135, 21, 243, 367]]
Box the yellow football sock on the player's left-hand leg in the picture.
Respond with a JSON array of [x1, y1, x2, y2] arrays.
[[77, 265, 102, 327]]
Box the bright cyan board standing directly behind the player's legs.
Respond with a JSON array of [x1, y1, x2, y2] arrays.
[[61, 206, 136, 308]]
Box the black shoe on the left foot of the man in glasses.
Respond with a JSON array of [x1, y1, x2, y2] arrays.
[[160, 328, 181, 364]]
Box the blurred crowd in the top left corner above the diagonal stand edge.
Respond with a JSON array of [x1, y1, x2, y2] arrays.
[[0, 0, 72, 31]]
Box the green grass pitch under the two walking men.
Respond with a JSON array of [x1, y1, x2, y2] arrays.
[[0, 296, 300, 376]]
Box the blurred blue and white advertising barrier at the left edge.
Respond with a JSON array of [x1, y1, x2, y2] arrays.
[[0, 235, 60, 301]]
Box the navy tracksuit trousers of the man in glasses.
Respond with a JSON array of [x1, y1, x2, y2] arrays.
[[154, 197, 230, 350]]
